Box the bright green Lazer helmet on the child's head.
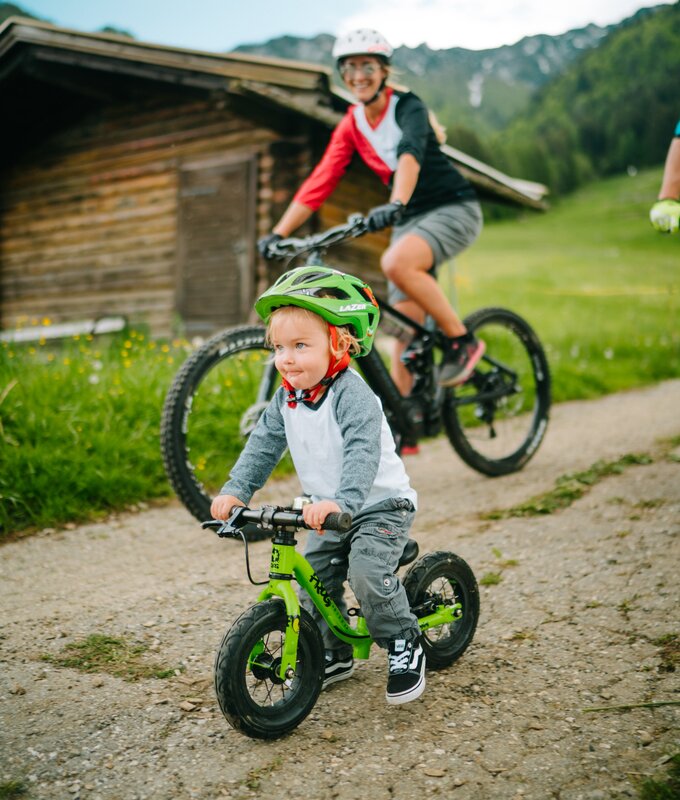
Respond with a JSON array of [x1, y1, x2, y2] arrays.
[[255, 265, 380, 356]]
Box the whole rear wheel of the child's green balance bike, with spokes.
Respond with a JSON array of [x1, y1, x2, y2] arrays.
[[404, 551, 479, 669]]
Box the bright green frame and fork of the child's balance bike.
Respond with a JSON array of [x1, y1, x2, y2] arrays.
[[255, 531, 462, 681]]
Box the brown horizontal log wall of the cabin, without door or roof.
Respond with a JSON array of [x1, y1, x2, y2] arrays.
[[0, 90, 386, 336]]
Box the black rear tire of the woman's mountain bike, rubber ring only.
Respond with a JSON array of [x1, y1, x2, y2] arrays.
[[442, 308, 551, 478]]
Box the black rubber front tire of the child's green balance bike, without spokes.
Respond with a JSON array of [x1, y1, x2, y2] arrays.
[[215, 599, 324, 739]]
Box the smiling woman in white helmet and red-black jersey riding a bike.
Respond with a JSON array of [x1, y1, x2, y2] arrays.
[[259, 28, 484, 394]]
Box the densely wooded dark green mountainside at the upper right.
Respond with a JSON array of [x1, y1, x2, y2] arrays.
[[494, 3, 680, 192]]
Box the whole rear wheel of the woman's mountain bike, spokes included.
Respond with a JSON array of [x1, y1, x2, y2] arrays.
[[442, 308, 550, 477]]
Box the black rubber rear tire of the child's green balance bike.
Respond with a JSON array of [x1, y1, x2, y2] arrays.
[[404, 550, 479, 669]]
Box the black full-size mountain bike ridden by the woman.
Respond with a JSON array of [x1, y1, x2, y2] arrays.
[[161, 214, 550, 535]]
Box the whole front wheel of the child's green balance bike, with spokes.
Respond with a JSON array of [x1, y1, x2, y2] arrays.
[[215, 600, 324, 739]]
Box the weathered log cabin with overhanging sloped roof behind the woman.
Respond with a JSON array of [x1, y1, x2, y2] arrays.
[[0, 18, 542, 336]]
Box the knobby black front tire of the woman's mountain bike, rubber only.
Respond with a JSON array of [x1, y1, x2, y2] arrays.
[[161, 325, 267, 540]]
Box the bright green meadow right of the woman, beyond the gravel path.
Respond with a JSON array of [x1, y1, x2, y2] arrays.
[[444, 169, 680, 402]]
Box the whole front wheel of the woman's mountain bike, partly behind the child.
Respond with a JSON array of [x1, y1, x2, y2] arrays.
[[161, 326, 279, 539]]
